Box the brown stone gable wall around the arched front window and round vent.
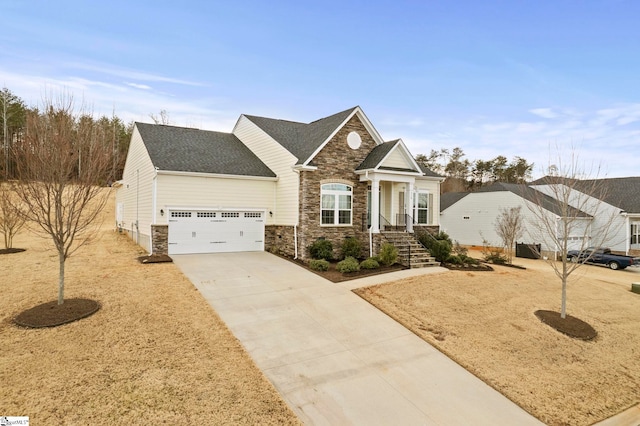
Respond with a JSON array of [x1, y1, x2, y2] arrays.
[[298, 116, 376, 259]]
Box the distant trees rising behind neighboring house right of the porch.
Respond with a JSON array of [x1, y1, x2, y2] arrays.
[[416, 147, 534, 192]]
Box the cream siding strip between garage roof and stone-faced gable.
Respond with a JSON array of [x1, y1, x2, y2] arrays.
[[233, 115, 300, 226]]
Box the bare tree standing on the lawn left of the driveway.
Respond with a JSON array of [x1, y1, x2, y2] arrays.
[[14, 95, 113, 304]]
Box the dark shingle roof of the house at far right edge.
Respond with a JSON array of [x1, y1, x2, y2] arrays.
[[531, 176, 640, 213]]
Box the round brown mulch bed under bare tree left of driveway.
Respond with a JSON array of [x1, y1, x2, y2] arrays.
[[13, 298, 100, 328]]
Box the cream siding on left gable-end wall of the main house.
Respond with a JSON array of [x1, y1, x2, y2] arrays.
[[116, 127, 155, 251]]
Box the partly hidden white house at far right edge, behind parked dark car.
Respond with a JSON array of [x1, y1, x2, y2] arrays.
[[530, 177, 640, 255]]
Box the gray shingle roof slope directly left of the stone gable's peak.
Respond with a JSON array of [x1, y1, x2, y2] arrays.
[[245, 107, 357, 164]]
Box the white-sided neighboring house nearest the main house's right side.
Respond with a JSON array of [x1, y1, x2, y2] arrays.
[[440, 183, 593, 252]]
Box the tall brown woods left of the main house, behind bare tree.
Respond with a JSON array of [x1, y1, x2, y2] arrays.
[[0, 87, 133, 184]]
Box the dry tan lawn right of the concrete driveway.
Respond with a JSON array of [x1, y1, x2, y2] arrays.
[[357, 255, 640, 425]]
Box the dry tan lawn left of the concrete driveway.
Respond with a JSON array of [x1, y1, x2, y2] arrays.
[[0, 191, 299, 425]]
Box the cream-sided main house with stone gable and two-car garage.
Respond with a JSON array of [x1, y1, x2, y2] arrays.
[[116, 107, 443, 258]]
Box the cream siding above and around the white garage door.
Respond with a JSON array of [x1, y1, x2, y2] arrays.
[[156, 174, 276, 224]]
